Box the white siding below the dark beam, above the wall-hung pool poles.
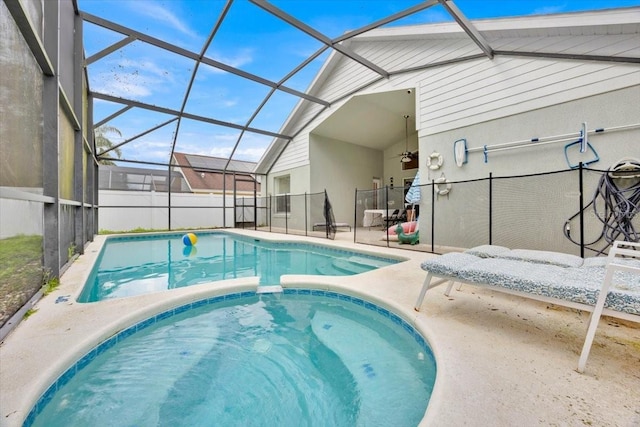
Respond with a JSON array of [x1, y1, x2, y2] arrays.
[[418, 57, 640, 136]]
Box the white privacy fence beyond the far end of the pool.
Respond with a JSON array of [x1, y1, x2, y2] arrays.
[[98, 190, 234, 231]]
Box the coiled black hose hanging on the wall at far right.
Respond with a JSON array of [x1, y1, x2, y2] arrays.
[[564, 169, 640, 255]]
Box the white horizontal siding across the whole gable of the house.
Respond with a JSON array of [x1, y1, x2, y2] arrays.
[[262, 14, 640, 177]]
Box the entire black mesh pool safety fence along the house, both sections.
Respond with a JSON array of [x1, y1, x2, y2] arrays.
[[235, 165, 640, 257]]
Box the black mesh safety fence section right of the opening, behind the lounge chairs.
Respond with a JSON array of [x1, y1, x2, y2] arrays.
[[354, 165, 640, 257]]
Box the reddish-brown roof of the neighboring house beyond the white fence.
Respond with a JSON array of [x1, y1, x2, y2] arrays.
[[173, 152, 260, 193]]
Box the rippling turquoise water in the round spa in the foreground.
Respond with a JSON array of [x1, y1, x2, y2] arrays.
[[31, 289, 436, 427]]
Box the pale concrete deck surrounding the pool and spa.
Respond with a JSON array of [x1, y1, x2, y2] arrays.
[[0, 230, 640, 427]]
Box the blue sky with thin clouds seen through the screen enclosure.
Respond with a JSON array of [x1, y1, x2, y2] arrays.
[[78, 0, 640, 167]]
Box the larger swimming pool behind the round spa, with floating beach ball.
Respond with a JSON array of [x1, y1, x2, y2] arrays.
[[78, 231, 400, 302]]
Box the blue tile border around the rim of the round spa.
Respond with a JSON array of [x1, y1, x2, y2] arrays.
[[27, 288, 433, 427]]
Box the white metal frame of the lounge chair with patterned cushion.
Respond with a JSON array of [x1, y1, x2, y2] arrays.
[[414, 241, 640, 373]]
